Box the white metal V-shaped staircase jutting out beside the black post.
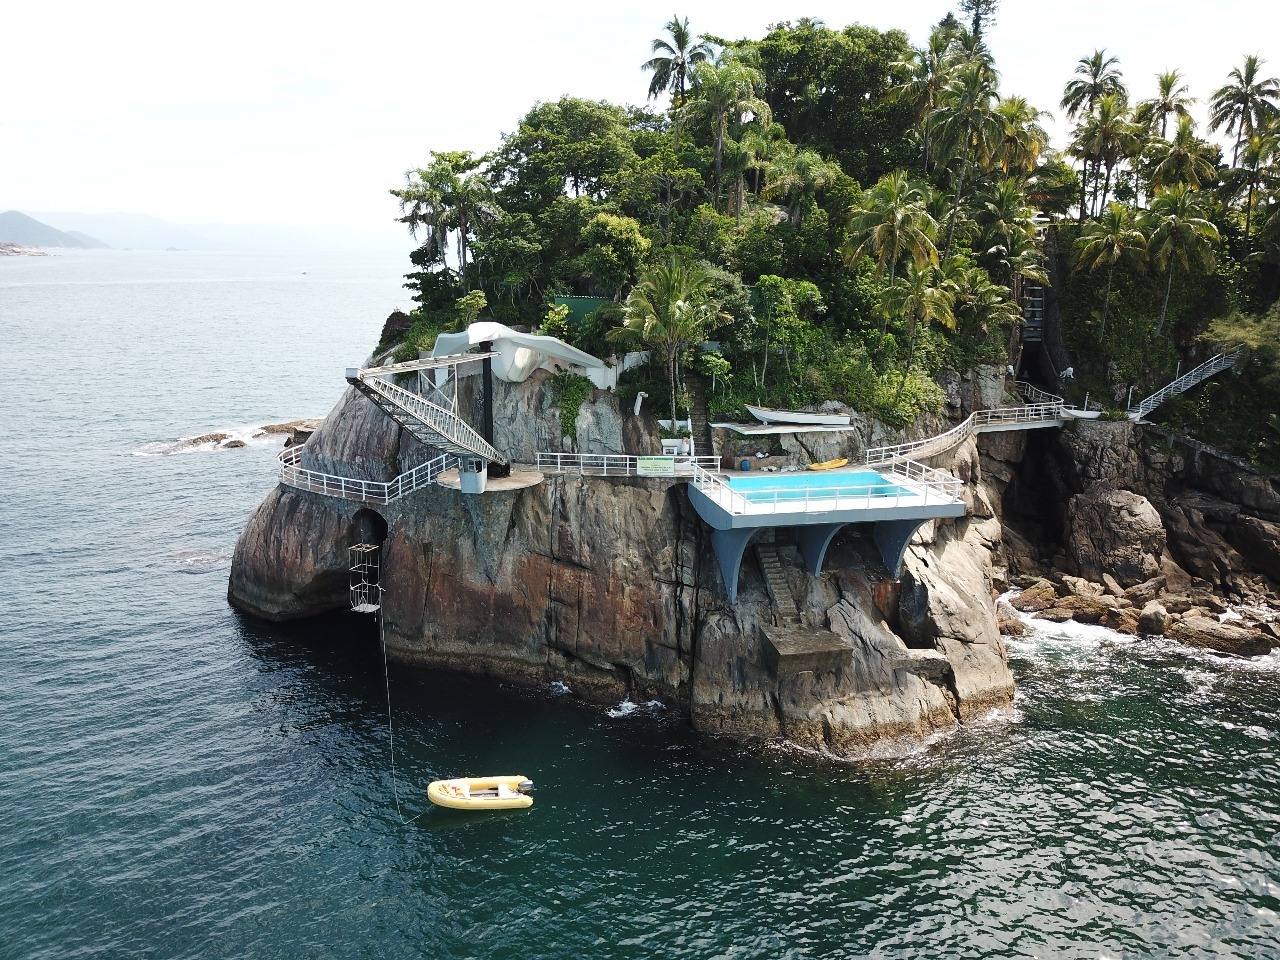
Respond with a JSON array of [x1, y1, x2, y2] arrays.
[[347, 353, 507, 463]]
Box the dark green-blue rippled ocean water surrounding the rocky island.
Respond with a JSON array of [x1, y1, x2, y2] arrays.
[[0, 252, 1280, 960]]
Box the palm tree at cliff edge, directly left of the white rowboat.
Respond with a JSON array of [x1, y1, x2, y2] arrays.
[[608, 256, 728, 425]]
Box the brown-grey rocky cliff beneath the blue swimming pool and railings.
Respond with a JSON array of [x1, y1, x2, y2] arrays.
[[229, 371, 1024, 754]]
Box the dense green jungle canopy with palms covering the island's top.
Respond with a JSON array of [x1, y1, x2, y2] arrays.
[[388, 8, 1280, 467]]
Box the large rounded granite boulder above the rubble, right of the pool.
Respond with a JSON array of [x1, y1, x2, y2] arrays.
[[1066, 486, 1166, 586]]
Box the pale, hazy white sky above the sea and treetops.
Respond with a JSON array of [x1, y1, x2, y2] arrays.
[[0, 0, 1280, 248]]
